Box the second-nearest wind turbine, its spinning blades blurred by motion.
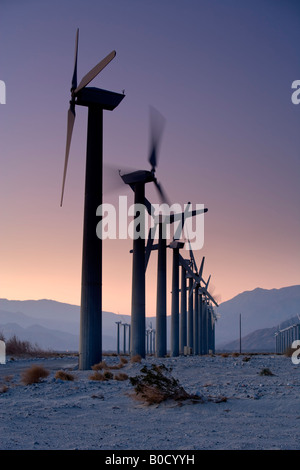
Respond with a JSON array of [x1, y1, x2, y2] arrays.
[[120, 108, 167, 357]]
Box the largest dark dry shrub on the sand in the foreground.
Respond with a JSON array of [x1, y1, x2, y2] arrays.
[[129, 364, 201, 405]]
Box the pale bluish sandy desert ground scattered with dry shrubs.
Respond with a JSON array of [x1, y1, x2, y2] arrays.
[[0, 355, 300, 451]]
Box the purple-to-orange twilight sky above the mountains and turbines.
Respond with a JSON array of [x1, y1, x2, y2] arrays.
[[0, 0, 300, 316]]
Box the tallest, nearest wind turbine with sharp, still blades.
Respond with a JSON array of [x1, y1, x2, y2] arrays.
[[61, 29, 124, 370]]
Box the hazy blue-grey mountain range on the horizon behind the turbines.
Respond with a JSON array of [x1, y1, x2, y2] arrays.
[[0, 285, 300, 351]]
